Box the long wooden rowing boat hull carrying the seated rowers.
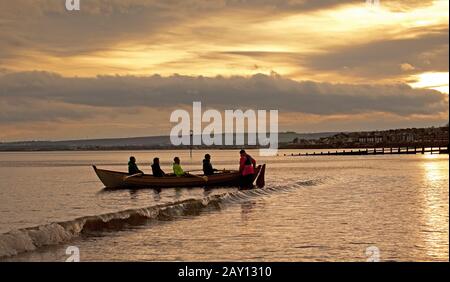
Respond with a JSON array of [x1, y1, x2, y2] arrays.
[[93, 164, 266, 189]]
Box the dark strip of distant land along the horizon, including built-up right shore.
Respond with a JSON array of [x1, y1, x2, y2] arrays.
[[0, 125, 449, 152]]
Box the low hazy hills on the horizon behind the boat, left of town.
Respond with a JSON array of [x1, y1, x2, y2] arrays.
[[0, 132, 336, 151]]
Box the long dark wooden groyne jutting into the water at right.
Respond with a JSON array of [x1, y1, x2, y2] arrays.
[[284, 147, 448, 156]]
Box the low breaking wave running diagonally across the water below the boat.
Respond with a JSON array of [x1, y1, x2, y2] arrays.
[[0, 181, 315, 258]]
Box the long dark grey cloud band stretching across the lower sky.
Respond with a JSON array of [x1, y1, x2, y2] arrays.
[[0, 72, 448, 119]]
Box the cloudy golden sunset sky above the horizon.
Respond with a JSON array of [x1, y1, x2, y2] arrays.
[[0, 0, 449, 142]]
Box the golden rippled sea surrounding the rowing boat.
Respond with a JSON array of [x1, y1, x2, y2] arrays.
[[0, 150, 449, 261]]
